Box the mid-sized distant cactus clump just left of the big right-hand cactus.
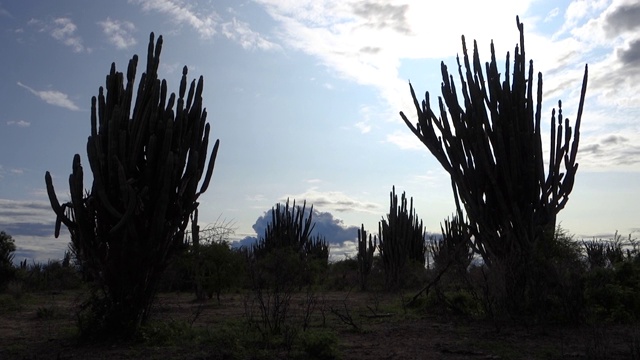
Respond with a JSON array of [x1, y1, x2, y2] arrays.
[[378, 186, 426, 288]]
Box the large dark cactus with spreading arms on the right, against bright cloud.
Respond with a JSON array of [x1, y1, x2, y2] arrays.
[[400, 18, 588, 312]]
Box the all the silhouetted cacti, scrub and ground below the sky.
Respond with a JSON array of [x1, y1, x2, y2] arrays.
[[0, 16, 640, 359]]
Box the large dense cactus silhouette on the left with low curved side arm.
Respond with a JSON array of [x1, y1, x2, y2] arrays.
[[45, 33, 219, 335]]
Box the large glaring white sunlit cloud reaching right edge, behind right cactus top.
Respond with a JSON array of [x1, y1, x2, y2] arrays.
[[255, 0, 640, 174]]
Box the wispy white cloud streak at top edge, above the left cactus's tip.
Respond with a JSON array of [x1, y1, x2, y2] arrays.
[[129, 0, 221, 39]]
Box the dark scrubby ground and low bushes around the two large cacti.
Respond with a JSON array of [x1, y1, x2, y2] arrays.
[[0, 232, 640, 359]]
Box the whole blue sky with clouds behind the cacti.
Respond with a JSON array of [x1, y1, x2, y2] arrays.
[[0, 0, 640, 261]]
